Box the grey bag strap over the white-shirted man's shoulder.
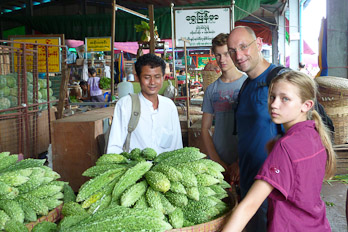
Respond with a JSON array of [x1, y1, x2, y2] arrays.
[[122, 93, 141, 152]]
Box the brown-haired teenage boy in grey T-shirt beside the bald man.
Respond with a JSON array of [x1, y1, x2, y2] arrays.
[[201, 33, 247, 185]]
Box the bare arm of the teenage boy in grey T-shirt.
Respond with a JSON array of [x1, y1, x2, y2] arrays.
[[201, 113, 228, 171]]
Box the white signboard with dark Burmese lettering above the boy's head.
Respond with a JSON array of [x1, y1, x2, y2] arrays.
[[174, 8, 231, 47]]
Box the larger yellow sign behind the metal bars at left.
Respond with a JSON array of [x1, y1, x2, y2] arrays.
[[11, 37, 61, 73]]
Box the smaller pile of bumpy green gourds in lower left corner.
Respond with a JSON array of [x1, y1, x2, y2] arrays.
[[0, 152, 75, 231]]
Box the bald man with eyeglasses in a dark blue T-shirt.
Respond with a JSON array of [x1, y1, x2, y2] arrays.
[[228, 26, 277, 232]]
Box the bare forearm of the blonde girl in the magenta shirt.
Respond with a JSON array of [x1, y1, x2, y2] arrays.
[[222, 180, 273, 232]]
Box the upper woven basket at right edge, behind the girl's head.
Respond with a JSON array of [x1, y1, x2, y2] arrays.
[[315, 76, 348, 107]]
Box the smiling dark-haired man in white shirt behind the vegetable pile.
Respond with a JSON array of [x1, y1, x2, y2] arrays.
[[107, 54, 182, 154]]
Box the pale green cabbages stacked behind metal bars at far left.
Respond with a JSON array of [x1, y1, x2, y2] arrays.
[[0, 72, 56, 110]]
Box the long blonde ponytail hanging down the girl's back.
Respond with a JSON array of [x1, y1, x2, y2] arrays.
[[311, 110, 336, 180]]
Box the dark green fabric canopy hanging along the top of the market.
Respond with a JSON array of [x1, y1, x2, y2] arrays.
[[0, 0, 286, 42]]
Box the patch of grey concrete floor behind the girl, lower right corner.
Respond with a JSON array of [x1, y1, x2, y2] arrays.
[[321, 182, 348, 232]]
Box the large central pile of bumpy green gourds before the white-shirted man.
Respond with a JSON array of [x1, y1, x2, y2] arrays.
[[60, 147, 230, 231]]
